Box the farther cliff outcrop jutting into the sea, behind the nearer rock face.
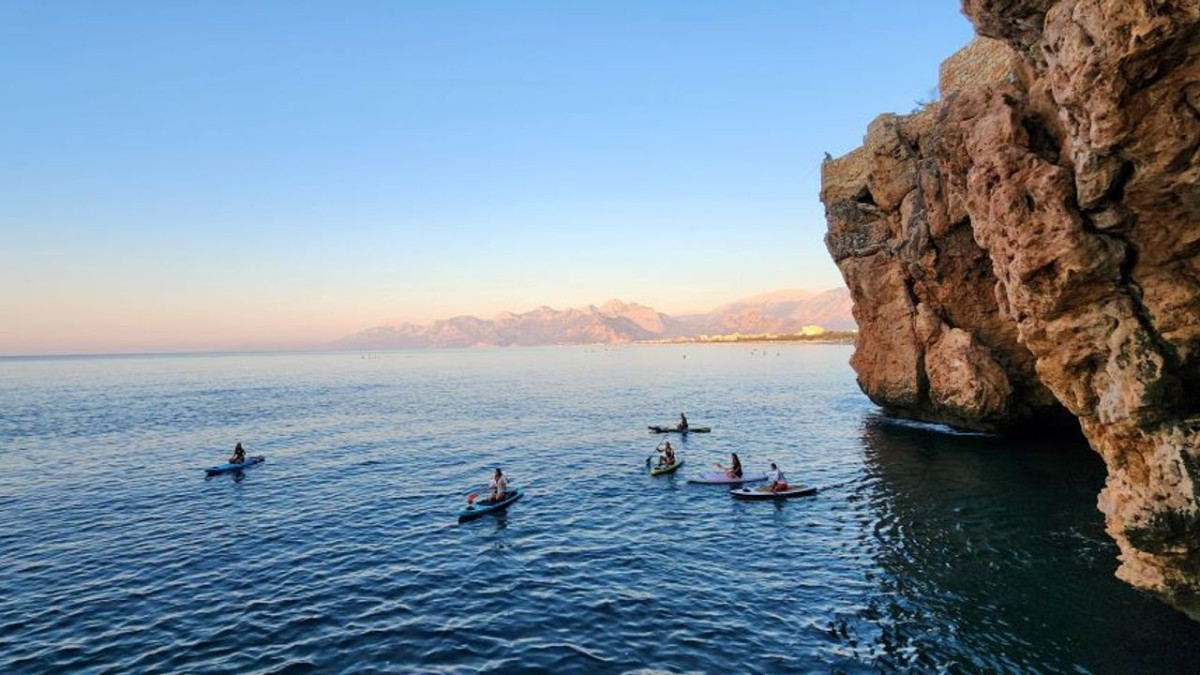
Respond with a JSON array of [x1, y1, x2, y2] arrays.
[[822, 79, 1064, 431]]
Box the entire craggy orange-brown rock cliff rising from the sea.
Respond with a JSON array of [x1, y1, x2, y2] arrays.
[[821, 0, 1200, 617]]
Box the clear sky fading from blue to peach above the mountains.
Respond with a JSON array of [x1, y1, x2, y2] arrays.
[[0, 0, 972, 354]]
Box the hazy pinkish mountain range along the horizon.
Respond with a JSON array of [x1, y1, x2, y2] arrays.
[[335, 288, 856, 350]]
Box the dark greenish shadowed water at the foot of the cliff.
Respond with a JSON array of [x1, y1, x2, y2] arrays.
[[838, 414, 1200, 673]]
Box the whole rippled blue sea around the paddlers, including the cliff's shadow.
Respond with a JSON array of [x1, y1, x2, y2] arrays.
[[0, 345, 1200, 673]]
